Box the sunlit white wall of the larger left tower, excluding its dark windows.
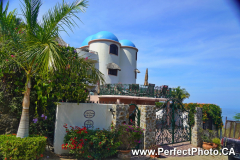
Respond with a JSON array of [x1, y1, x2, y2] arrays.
[[89, 40, 121, 84]]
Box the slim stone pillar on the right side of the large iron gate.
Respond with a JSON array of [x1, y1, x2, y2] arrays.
[[191, 107, 203, 147]]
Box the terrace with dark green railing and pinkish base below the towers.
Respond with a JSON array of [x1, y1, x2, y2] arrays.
[[90, 83, 172, 105]]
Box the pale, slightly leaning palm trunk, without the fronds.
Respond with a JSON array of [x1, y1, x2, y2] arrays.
[[17, 76, 31, 138]]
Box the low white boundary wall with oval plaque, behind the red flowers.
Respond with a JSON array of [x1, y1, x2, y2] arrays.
[[54, 103, 113, 154]]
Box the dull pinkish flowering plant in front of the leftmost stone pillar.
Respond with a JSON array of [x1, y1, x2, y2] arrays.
[[116, 124, 144, 150]]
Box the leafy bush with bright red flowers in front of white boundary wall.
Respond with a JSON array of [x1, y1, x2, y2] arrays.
[[62, 124, 120, 159]]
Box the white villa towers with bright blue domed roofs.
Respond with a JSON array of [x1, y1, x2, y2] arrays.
[[77, 31, 140, 84]]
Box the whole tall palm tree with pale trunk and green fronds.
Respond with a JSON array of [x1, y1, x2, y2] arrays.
[[0, 0, 87, 138]]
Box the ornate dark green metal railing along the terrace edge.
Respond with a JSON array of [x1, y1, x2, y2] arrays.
[[100, 84, 172, 98]]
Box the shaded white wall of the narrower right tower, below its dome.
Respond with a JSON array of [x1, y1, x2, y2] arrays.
[[119, 47, 137, 84]]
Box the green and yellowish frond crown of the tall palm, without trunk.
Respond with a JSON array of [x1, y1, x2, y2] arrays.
[[19, 0, 86, 73]]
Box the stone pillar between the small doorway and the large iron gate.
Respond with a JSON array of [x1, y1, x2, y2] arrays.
[[138, 105, 156, 149]]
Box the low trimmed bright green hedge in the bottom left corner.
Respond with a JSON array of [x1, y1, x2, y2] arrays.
[[0, 135, 46, 160]]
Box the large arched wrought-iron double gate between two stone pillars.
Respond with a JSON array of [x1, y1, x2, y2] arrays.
[[156, 99, 191, 145]]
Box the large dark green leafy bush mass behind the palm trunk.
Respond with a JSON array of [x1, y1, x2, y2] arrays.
[[0, 46, 102, 142]]
